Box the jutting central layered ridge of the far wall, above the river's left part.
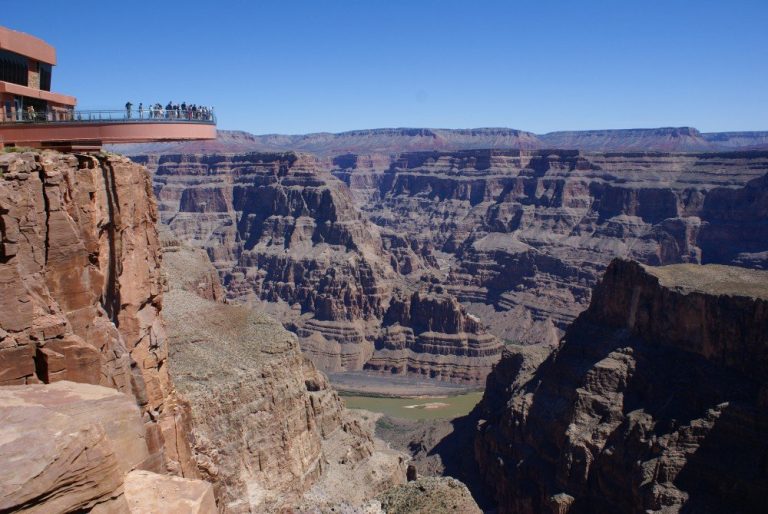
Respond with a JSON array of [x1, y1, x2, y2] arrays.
[[140, 150, 501, 383]]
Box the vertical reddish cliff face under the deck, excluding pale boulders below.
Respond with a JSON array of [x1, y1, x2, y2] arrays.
[[0, 152, 196, 476]]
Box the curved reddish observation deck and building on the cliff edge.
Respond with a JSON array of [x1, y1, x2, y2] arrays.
[[0, 27, 216, 150]]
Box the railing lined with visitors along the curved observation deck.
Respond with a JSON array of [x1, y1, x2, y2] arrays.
[[0, 109, 216, 125]]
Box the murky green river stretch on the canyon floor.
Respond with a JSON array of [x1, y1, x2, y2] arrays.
[[341, 392, 483, 418]]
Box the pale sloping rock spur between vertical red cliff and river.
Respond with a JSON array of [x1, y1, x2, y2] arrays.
[[164, 239, 405, 513]]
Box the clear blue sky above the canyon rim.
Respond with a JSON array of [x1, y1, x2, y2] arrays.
[[0, 0, 768, 134]]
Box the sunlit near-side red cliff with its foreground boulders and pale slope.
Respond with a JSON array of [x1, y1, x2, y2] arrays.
[[0, 147, 412, 508]]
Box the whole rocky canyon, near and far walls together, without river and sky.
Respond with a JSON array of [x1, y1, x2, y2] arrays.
[[6, 125, 768, 514]]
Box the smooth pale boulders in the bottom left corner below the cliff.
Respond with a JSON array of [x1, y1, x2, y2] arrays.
[[0, 381, 216, 514]]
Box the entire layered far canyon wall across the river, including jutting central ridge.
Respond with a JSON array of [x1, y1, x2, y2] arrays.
[[127, 138, 768, 386]]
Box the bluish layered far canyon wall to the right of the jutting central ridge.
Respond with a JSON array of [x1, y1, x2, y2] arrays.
[[333, 150, 768, 343]]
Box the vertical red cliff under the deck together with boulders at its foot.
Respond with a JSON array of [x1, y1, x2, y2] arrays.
[[0, 152, 210, 512]]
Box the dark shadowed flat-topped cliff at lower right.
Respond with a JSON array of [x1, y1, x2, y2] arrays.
[[475, 260, 768, 513]]
